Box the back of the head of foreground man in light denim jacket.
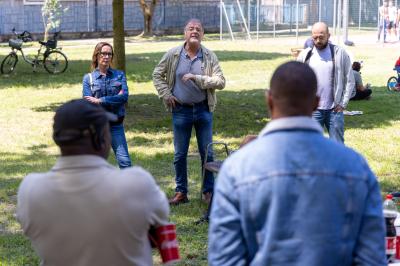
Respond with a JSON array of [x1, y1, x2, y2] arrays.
[[267, 61, 319, 119]]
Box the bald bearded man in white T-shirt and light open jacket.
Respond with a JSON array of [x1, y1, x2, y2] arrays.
[[297, 22, 354, 143]]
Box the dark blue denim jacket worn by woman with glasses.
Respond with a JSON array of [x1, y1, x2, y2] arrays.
[[83, 68, 129, 117]]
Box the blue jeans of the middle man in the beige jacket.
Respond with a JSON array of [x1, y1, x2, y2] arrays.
[[172, 102, 214, 194]]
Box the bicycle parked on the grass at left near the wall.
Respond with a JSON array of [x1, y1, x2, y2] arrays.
[[0, 29, 68, 74]]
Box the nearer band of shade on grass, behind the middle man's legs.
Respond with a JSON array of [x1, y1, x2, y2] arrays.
[[33, 87, 400, 138]]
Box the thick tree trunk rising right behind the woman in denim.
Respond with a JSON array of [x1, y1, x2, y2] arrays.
[[112, 0, 125, 72]]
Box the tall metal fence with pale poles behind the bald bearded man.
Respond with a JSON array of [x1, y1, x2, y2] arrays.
[[220, 0, 382, 39]]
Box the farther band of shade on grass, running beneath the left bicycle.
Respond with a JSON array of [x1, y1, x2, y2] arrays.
[[0, 50, 288, 90]]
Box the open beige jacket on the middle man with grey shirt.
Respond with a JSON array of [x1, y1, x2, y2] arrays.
[[153, 44, 225, 112]]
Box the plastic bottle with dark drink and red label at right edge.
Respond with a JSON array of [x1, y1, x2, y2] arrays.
[[383, 194, 397, 262]]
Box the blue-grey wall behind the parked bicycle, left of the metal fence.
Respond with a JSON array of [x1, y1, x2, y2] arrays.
[[0, 0, 219, 35]]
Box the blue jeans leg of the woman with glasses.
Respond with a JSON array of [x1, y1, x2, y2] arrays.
[[110, 123, 132, 169]]
